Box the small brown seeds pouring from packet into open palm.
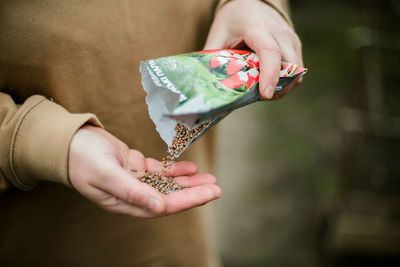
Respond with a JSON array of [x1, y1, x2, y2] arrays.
[[132, 122, 209, 195]]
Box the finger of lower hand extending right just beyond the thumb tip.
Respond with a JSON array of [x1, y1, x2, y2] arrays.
[[165, 184, 221, 214]]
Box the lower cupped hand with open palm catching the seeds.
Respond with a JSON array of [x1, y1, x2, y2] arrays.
[[68, 125, 221, 218]]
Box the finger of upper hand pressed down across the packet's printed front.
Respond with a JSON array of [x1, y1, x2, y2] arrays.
[[245, 33, 281, 99]]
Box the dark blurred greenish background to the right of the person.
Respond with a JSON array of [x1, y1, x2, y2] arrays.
[[215, 0, 400, 267]]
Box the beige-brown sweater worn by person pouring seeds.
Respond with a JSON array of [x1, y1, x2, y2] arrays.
[[0, 0, 289, 266]]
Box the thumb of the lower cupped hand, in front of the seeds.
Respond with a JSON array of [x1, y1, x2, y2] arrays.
[[96, 166, 165, 214]]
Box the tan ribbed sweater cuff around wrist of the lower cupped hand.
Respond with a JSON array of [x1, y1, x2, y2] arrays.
[[9, 98, 102, 190]]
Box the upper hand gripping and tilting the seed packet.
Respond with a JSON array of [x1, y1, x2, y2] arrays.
[[204, 0, 303, 99]]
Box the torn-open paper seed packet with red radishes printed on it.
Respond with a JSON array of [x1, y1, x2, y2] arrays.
[[140, 49, 307, 156]]
